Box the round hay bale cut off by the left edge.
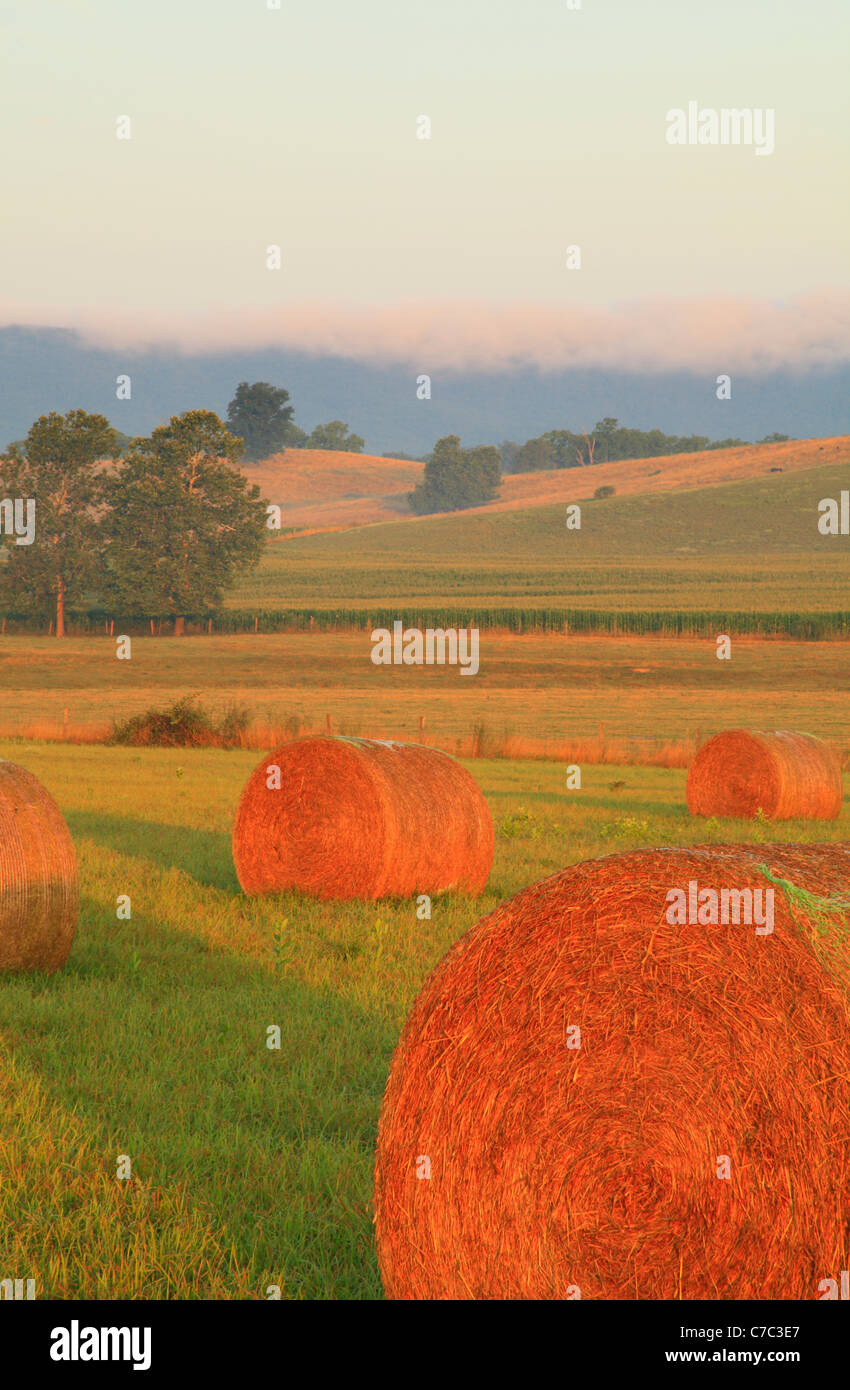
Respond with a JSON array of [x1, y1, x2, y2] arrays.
[[0, 760, 79, 972]]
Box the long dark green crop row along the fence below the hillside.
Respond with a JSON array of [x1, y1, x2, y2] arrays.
[[0, 606, 850, 642]]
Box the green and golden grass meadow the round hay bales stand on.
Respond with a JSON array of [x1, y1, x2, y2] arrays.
[[0, 744, 850, 1298]]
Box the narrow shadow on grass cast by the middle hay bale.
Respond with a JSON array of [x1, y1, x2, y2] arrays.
[[65, 810, 242, 894]]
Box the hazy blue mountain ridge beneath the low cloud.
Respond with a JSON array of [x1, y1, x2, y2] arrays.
[[0, 325, 850, 455]]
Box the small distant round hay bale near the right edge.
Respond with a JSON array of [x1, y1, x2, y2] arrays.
[[686, 728, 843, 820]]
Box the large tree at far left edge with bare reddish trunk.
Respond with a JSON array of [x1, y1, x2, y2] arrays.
[[0, 410, 117, 637]]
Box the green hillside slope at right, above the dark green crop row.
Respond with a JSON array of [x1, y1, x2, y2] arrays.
[[229, 458, 850, 613]]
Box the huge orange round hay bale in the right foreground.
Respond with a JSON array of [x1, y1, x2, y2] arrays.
[[375, 845, 850, 1300]]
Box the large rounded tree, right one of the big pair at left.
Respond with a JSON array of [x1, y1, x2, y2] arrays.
[[106, 410, 268, 635]]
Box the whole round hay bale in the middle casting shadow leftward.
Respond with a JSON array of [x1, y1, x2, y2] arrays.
[[233, 737, 493, 898]]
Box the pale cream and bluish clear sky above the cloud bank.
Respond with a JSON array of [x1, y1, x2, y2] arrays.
[[0, 0, 850, 357]]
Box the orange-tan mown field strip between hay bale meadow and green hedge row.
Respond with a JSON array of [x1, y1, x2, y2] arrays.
[[0, 630, 850, 760]]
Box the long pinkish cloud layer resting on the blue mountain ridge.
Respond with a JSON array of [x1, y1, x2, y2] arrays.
[[0, 289, 850, 374]]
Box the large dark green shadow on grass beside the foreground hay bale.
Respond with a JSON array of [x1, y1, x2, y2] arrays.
[[0, 898, 396, 1298]]
